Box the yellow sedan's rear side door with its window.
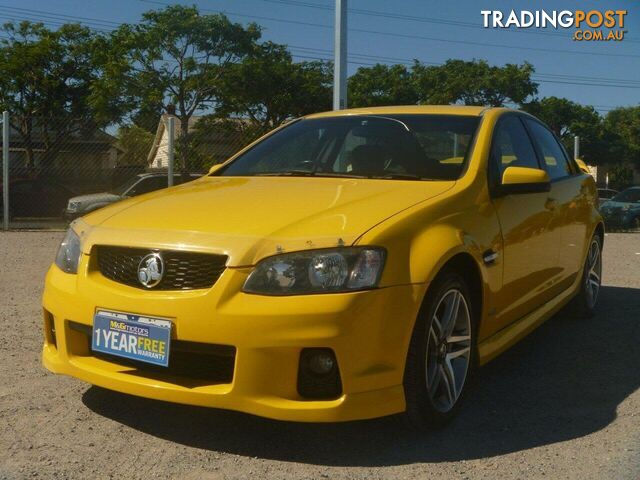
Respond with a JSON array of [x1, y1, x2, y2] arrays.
[[524, 117, 591, 286]]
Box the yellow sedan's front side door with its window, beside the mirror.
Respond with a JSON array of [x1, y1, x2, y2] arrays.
[[488, 114, 560, 330]]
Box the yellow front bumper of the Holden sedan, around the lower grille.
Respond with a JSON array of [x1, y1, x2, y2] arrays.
[[43, 255, 426, 422]]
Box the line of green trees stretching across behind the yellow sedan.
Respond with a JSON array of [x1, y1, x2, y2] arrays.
[[0, 9, 640, 178]]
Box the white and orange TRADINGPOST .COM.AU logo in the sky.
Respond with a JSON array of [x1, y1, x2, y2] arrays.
[[480, 10, 627, 42]]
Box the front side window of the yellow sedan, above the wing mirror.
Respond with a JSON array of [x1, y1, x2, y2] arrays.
[[490, 116, 540, 185]]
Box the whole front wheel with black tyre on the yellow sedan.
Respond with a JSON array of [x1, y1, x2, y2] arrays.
[[404, 271, 476, 428]]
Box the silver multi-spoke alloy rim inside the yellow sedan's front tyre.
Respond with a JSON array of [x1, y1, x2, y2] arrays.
[[425, 289, 471, 413]]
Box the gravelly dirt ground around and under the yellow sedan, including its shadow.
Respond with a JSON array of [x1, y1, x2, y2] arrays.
[[0, 232, 640, 480]]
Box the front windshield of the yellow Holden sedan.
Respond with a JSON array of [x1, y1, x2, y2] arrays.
[[215, 115, 480, 180]]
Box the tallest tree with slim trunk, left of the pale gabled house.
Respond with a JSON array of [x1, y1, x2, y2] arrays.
[[103, 5, 260, 171]]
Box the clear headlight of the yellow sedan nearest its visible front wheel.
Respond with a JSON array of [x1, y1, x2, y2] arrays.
[[243, 247, 385, 295]]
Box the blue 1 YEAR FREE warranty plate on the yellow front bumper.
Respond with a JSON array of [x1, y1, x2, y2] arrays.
[[91, 310, 171, 367]]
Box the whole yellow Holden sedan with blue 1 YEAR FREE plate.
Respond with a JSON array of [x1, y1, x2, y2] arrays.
[[43, 106, 604, 426]]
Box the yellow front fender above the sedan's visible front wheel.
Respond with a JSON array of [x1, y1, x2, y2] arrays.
[[357, 186, 503, 340]]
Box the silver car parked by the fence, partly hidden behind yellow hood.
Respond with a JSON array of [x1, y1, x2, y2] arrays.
[[64, 173, 201, 220]]
